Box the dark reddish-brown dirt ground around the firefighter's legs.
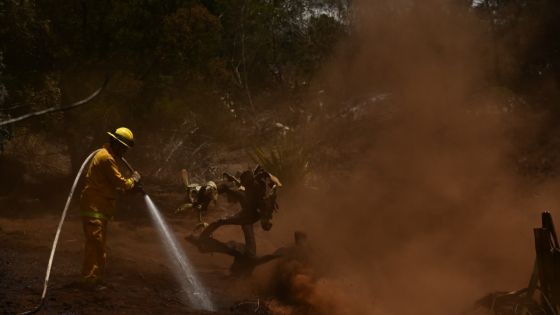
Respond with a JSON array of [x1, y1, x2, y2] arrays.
[[0, 189, 282, 314]]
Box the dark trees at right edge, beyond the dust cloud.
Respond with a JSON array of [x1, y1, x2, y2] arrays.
[[474, 0, 560, 177]]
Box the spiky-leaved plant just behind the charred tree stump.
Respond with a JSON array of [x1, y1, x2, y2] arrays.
[[247, 137, 310, 186]]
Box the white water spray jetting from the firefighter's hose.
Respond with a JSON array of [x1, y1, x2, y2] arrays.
[[121, 158, 216, 311]]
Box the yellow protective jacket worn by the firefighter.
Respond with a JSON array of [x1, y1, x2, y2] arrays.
[[80, 145, 134, 220]]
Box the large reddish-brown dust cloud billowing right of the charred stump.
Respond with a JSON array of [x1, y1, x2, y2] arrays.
[[260, 0, 560, 315]]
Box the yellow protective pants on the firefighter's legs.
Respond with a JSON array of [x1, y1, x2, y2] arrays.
[[82, 217, 107, 285]]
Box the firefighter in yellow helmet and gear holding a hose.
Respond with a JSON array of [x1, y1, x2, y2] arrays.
[[80, 127, 140, 288]]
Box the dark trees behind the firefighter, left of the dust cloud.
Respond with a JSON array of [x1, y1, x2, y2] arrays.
[[0, 0, 347, 173]]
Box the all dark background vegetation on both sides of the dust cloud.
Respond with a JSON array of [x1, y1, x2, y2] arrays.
[[0, 0, 560, 186]]
